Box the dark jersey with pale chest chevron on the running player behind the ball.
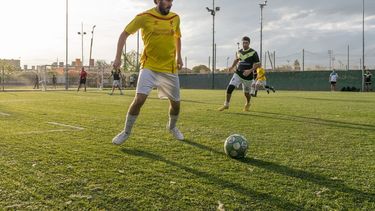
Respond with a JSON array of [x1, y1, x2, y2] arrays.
[[236, 48, 259, 80]]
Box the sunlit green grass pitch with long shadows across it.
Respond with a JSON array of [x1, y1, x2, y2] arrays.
[[0, 90, 375, 210]]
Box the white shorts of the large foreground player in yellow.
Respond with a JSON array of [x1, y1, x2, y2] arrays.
[[136, 69, 180, 102]]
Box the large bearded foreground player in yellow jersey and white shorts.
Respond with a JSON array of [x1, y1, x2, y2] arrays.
[[112, 0, 184, 145]]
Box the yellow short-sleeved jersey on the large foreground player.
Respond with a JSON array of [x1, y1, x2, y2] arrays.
[[125, 8, 181, 73]]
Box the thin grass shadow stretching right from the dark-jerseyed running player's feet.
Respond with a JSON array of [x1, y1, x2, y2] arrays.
[[224, 111, 375, 131]]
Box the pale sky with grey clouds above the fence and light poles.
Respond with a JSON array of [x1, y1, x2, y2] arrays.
[[0, 0, 375, 68]]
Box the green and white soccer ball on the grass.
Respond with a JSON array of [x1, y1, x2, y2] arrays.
[[224, 134, 249, 159]]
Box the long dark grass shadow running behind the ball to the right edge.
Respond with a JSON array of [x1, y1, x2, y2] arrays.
[[181, 140, 375, 202]]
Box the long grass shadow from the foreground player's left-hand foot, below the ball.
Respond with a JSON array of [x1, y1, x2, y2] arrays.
[[122, 149, 302, 210]]
